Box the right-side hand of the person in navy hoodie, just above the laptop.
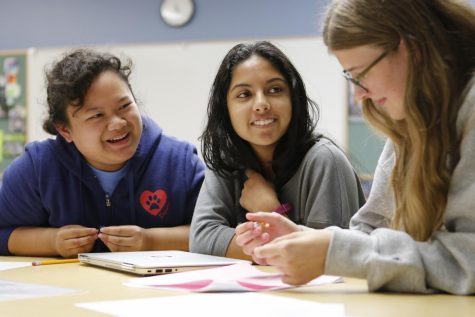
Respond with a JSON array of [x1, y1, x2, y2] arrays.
[[98, 226, 147, 252]]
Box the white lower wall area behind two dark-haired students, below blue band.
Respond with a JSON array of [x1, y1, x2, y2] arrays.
[[28, 37, 346, 153]]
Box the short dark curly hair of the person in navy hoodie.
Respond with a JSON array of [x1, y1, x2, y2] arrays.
[[43, 49, 133, 135]]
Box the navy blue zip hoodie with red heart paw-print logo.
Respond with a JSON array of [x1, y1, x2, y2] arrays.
[[0, 117, 204, 255]]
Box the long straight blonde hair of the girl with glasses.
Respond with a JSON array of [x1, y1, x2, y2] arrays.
[[323, 0, 475, 241]]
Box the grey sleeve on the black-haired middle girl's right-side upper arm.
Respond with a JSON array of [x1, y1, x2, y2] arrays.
[[280, 138, 365, 229]]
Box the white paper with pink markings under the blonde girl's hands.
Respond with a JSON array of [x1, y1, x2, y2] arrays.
[[124, 263, 341, 292]]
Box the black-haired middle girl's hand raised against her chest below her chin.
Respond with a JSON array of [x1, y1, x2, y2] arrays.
[[239, 170, 280, 212]]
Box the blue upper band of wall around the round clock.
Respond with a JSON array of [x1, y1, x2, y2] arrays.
[[0, 0, 328, 50]]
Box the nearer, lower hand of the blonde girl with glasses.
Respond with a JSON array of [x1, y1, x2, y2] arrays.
[[253, 230, 333, 285]]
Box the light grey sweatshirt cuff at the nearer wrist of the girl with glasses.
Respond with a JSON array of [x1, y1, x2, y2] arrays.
[[325, 227, 373, 279]]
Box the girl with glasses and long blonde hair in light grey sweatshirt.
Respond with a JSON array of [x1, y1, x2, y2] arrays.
[[238, 0, 475, 294]]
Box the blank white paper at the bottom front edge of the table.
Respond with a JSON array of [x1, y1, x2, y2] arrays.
[[76, 293, 345, 317]]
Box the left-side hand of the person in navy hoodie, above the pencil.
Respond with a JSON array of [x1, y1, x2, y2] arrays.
[[54, 225, 97, 258]]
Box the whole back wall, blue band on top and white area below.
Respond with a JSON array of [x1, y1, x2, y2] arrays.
[[5, 0, 346, 152]]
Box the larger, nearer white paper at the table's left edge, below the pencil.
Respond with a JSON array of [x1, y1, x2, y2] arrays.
[[0, 278, 76, 301]]
